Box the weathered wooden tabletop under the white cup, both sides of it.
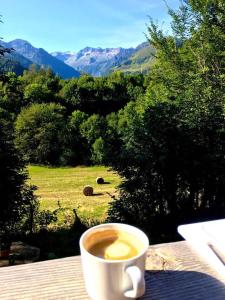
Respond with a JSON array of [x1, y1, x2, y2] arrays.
[[0, 242, 225, 300]]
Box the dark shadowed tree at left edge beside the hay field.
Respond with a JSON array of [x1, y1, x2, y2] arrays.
[[0, 109, 35, 235]]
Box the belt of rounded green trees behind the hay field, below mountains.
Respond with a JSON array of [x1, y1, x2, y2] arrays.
[[0, 58, 146, 165]]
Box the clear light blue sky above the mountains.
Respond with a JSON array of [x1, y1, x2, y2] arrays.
[[0, 0, 179, 52]]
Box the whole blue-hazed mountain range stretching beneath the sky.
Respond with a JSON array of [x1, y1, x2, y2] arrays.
[[0, 39, 154, 79]]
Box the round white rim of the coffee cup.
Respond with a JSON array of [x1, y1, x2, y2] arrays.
[[79, 223, 149, 263]]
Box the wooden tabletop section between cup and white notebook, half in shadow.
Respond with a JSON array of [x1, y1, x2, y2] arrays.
[[143, 242, 225, 300]]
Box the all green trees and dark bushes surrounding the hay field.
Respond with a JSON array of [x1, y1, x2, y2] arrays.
[[0, 0, 225, 258]]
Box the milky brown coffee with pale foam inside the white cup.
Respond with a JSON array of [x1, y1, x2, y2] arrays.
[[86, 229, 143, 260]]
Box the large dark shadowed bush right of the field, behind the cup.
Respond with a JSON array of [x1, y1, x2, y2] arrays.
[[109, 103, 225, 242]]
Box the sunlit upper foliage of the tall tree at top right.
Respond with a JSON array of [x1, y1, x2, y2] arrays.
[[145, 0, 225, 106]]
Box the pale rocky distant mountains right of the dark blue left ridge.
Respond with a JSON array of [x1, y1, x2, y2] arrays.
[[51, 42, 155, 76]]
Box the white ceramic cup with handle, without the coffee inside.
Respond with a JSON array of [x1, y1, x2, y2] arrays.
[[80, 223, 149, 300]]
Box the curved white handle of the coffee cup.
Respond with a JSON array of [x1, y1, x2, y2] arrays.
[[124, 266, 145, 299]]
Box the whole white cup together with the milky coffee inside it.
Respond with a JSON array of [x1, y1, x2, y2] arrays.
[[80, 223, 149, 300]]
